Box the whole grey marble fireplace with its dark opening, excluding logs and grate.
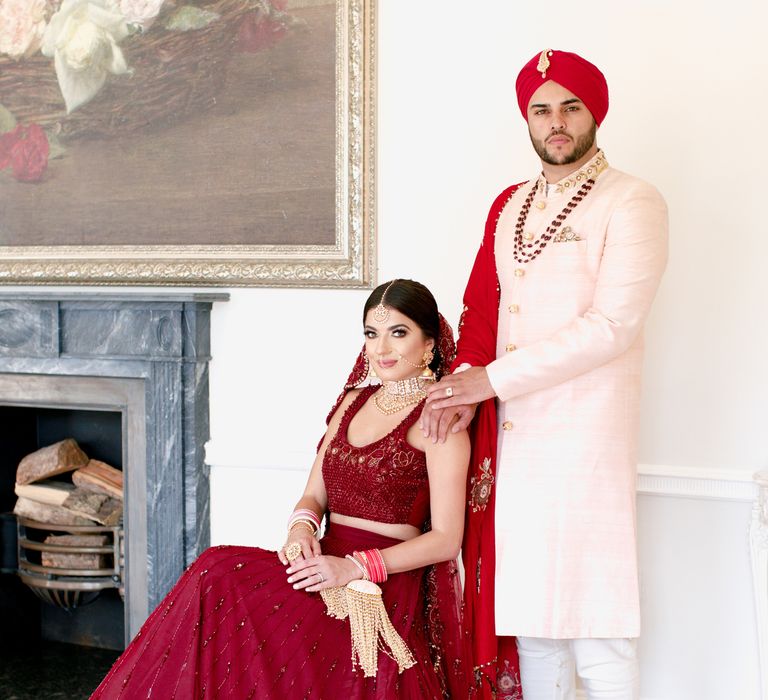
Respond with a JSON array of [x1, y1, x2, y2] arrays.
[[0, 290, 228, 700]]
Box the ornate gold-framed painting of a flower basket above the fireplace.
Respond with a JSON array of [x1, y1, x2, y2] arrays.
[[0, 0, 376, 287]]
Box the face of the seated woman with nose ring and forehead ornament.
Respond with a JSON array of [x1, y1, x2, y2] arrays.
[[363, 307, 435, 382]]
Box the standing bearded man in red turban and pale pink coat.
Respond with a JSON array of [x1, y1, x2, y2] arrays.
[[422, 50, 667, 700]]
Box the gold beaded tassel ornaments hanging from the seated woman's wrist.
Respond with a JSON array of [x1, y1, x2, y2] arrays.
[[320, 580, 416, 678]]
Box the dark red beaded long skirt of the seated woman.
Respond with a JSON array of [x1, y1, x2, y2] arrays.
[[91, 524, 470, 700]]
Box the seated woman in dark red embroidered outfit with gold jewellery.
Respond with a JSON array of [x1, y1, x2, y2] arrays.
[[92, 279, 471, 700]]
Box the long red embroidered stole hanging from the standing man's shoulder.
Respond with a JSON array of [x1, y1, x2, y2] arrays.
[[452, 183, 523, 700]]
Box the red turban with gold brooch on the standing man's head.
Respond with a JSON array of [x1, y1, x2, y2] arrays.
[[516, 49, 608, 126]]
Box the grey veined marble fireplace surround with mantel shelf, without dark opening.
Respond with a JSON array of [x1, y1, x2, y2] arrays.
[[0, 291, 229, 638]]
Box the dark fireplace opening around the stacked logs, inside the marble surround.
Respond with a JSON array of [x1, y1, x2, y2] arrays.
[[0, 405, 125, 655]]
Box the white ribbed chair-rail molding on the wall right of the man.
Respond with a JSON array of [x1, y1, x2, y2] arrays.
[[637, 464, 758, 503]]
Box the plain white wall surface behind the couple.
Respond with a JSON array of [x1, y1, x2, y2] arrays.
[[208, 0, 768, 700]]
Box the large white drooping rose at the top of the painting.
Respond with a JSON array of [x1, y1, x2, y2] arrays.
[[42, 0, 130, 113]]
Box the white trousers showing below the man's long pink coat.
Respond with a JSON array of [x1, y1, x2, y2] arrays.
[[517, 637, 640, 700]]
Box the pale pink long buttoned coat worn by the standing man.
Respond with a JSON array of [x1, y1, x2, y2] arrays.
[[487, 153, 667, 638]]
